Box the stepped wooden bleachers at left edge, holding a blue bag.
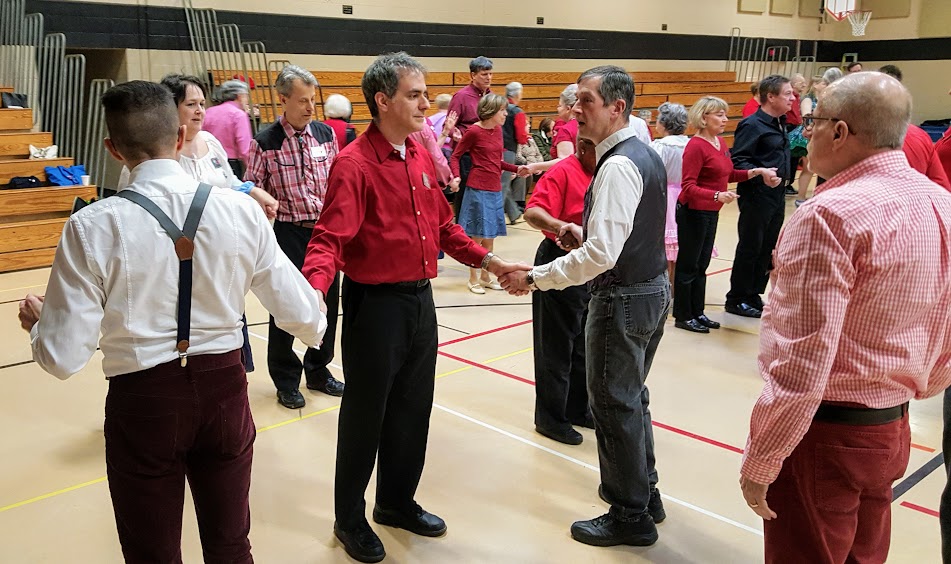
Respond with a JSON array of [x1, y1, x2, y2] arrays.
[[0, 106, 96, 272]]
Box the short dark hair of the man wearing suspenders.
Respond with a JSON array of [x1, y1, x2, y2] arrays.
[[101, 80, 179, 159]]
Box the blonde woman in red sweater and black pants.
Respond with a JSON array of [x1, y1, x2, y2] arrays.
[[674, 96, 779, 333]]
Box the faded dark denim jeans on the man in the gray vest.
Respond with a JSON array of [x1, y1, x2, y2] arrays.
[[585, 272, 670, 520]]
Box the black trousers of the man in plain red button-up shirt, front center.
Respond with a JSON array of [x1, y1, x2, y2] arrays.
[[334, 276, 437, 529]]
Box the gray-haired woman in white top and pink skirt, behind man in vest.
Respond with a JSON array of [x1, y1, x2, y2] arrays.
[[651, 102, 688, 285]]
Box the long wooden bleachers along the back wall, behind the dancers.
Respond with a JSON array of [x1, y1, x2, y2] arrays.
[[211, 70, 750, 146]]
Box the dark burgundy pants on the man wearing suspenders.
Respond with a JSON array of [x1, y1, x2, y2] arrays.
[[105, 351, 255, 564]]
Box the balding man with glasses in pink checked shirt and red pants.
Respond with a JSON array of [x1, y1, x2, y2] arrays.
[[740, 72, 951, 564]]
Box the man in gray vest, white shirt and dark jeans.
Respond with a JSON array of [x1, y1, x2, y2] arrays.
[[500, 66, 670, 546]]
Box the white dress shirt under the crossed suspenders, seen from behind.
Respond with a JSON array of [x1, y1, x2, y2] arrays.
[[31, 160, 327, 379]]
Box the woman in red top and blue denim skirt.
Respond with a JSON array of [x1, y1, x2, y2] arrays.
[[449, 94, 519, 294]]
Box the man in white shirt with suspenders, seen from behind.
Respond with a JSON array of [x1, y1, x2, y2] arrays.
[[20, 81, 327, 563]]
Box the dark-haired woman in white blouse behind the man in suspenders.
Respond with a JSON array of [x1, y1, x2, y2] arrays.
[[118, 74, 277, 219]]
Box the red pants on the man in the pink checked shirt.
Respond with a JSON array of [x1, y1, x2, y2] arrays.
[[764, 415, 911, 564]]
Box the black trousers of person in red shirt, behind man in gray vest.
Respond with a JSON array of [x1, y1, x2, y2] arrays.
[[532, 237, 591, 433]]
